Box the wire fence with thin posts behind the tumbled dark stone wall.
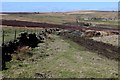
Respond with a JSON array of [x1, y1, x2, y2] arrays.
[[1, 27, 41, 44]]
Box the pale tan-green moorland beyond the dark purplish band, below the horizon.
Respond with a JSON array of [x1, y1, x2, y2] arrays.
[[2, 11, 118, 24]]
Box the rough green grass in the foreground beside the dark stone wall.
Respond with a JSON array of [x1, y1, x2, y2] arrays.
[[2, 27, 118, 78]]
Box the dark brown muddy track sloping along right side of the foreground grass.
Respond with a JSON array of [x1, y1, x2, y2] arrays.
[[58, 33, 120, 61]]
